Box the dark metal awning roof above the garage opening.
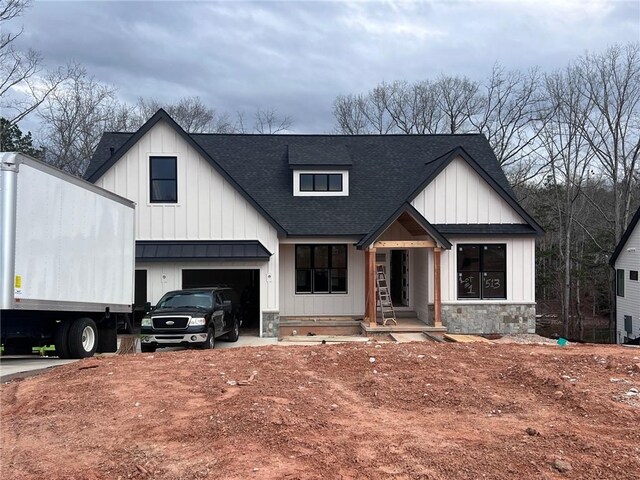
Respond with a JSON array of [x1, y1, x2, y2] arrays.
[[136, 240, 272, 262]]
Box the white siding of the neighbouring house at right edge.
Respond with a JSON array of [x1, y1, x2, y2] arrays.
[[616, 223, 640, 342]]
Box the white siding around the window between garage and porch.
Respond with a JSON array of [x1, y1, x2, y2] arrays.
[[280, 242, 364, 317]]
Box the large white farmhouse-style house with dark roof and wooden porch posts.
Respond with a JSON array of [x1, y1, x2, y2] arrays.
[[86, 110, 543, 336]]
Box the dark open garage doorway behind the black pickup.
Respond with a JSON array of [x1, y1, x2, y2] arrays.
[[182, 269, 260, 335]]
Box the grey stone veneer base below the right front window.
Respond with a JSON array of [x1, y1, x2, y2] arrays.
[[431, 303, 536, 334]]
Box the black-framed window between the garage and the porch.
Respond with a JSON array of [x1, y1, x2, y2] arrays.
[[296, 245, 347, 293]]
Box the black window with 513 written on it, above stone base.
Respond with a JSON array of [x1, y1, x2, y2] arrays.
[[458, 244, 507, 299]]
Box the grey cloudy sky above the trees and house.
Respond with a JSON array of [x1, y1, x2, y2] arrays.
[[10, 0, 640, 133]]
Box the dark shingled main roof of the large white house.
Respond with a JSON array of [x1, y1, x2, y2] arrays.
[[85, 111, 542, 242]]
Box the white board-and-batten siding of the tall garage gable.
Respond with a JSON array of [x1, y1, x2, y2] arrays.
[[96, 121, 279, 324]]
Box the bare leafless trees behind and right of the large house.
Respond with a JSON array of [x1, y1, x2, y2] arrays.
[[333, 43, 640, 339]]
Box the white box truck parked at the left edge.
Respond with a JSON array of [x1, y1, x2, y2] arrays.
[[0, 153, 135, 358]]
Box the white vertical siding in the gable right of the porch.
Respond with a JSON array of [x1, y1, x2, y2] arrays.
[[411, 157, 525, 224]]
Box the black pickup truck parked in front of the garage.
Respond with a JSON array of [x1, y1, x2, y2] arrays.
[[140, 287, 240, 352]]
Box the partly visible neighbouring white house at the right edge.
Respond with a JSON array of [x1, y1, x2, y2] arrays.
[[609, 204, 640, 343]]
